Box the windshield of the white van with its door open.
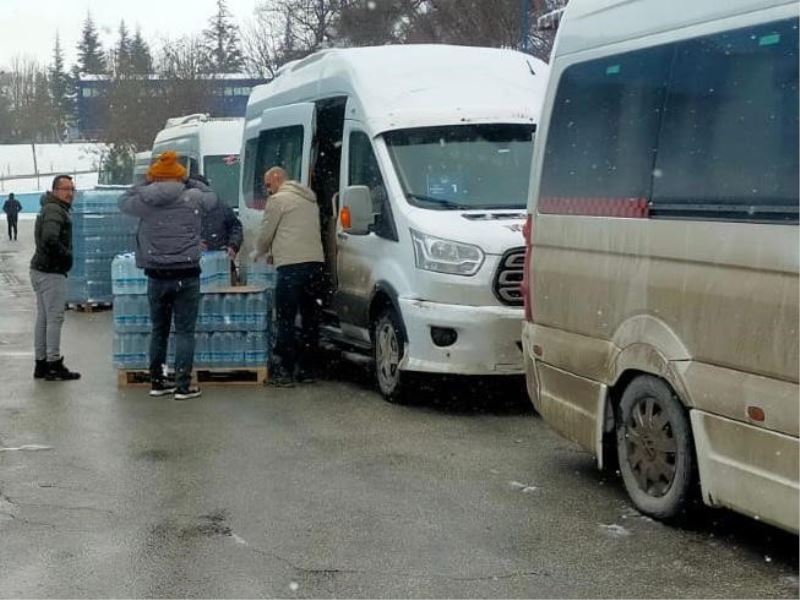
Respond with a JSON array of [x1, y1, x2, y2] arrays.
[[384, 123, 534, 210]]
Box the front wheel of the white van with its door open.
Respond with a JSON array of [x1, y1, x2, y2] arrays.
[[372, 308, 405, 403]]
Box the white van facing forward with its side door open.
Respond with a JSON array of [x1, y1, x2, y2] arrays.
[[239, 45, 548, 400]]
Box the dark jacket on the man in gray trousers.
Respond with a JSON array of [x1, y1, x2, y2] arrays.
[[31, 192, 72, 275]]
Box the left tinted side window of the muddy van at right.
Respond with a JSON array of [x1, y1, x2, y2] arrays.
[[539, 47, 672, 214]]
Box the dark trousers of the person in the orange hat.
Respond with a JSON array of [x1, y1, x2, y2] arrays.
[[147, 276, 200, 389]]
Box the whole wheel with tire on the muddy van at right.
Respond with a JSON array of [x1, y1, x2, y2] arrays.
[[616, 375, 696, 521]]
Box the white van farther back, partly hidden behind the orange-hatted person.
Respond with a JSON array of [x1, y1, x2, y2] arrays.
[[151, 114, 244, 207]]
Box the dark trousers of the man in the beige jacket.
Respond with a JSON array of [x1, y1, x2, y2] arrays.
[[275, 262, 325, 377]]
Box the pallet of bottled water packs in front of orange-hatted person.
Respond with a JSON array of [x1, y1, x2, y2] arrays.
[[112, 252, 274, 370]]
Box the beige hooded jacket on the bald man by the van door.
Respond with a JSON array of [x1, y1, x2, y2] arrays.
[[256, 181, 325, 267]]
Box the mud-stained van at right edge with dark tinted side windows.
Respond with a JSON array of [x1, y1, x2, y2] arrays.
[[523, 0, 800, 531]]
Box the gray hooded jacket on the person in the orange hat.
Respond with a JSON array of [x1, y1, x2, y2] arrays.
[[119, 181, 217, 276]]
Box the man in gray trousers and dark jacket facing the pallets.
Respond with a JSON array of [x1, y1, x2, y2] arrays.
[[31, 175, 81, 381]]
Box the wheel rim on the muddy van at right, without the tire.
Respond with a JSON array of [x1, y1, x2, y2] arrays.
[[625, 397, 678, 498]]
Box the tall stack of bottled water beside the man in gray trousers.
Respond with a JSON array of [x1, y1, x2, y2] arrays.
[[67, 188, 138, 304]]
